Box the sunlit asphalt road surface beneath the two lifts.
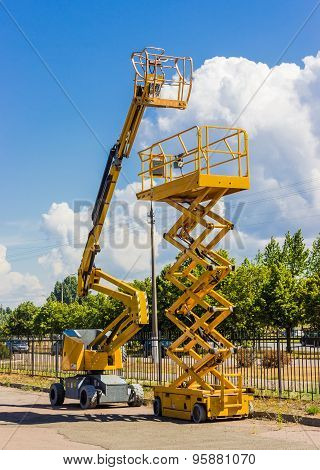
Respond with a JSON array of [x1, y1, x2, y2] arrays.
[[0, 387, 320, 450]]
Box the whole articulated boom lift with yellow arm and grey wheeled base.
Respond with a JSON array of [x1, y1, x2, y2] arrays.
[[50, 47, 192, 408]]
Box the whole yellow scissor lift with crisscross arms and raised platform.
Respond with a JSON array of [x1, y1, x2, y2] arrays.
[[137, 126, 252, 419]]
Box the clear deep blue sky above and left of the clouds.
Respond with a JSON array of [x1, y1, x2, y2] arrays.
[[0, 0, 320, 303]]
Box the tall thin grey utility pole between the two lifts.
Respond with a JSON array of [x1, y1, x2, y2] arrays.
[[149, 201, 159, 364]]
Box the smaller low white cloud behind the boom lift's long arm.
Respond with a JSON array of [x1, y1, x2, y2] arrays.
[[38, 183, 162, 280]]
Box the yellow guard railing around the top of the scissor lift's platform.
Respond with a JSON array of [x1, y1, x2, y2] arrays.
[[139, 126, 249, 191]]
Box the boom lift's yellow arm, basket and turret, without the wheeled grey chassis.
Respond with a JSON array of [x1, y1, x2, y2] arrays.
[[62, 47, 192, 371]]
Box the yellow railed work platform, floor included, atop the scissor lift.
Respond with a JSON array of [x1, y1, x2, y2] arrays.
[[137, 126, 250, 202]]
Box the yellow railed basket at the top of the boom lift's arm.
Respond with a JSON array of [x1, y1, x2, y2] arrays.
[[131, 47, 193, 107]]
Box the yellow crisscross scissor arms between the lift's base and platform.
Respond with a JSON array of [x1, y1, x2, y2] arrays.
[[165, 189, 236, 390]]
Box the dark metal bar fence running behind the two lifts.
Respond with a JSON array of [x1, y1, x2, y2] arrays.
[[0, 333, 320, 399]]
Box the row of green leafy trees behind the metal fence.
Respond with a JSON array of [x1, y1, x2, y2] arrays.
[[0, 230, 320, 337]]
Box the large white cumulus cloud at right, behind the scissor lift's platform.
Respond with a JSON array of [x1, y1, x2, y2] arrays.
[[140, 53, 320, 242]]
